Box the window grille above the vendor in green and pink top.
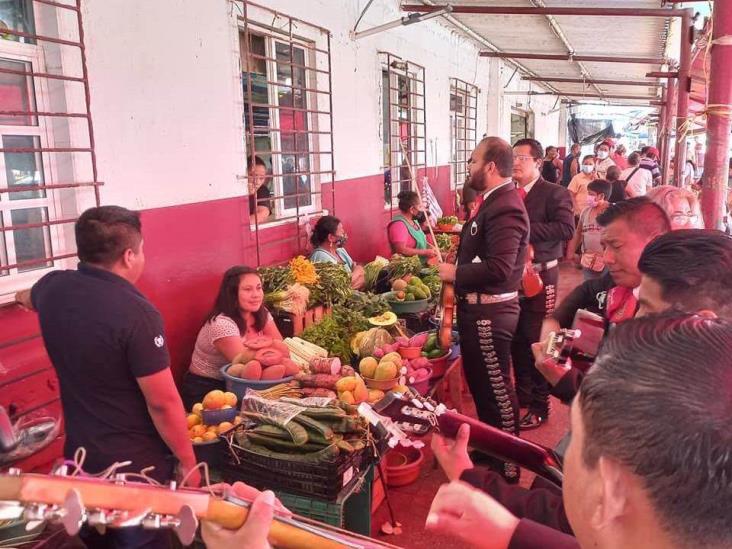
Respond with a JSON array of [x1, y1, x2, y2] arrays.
[[379, 52, 427, 213]]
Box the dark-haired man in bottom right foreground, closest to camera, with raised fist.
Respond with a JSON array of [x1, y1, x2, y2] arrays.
[[426, 314, 732, 549]]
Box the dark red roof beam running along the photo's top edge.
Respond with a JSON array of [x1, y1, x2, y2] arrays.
[[402, 4, 686, 17]]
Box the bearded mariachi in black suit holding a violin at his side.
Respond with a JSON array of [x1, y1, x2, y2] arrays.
[[439, 137, 538, 482]]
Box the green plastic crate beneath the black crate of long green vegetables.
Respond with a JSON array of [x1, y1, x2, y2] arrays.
[[276, 466, 374, 536]]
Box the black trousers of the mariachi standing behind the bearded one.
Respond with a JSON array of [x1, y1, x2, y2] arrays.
[[511, 267, 559, 418]]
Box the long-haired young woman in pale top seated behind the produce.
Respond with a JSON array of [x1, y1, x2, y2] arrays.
[[181, 265, 282, 410]]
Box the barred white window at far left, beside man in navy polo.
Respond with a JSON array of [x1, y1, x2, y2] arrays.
[[0, 0, 102, 286]]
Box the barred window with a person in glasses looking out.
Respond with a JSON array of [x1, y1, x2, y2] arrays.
[[238, 0, 335, 265]]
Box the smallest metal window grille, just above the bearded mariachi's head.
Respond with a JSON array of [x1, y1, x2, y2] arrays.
[[450, 78, 479, 189]]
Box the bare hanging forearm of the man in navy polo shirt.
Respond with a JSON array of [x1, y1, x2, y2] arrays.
[[136, 368, 200, 486]]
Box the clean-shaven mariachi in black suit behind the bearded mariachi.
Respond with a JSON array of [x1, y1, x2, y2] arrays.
[[511, 139, 574, 429]]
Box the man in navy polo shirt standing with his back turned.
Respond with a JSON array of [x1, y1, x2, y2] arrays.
[[17, 206, 200, 548]]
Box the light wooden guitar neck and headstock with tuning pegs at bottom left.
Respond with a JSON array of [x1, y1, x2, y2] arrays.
[[0, 465, 398, 549]]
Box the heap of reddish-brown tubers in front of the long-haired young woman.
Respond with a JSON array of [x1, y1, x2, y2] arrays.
[[226, 337, 300, 381]]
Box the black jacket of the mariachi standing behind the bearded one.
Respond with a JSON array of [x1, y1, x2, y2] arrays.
[[525, 177, 574, 263]]
